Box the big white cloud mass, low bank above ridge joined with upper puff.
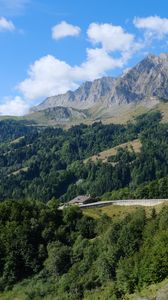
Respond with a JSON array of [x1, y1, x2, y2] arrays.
[[17, 23, 141, 100]]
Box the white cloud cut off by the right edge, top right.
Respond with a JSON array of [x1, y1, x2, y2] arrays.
[[133, 16, 168, 39]]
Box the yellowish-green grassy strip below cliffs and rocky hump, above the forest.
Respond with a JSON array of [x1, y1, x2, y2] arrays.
[[0, 102, 168, 128]]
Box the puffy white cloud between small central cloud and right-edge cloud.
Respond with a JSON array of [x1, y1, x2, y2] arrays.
[[87, 23, 134, 52]]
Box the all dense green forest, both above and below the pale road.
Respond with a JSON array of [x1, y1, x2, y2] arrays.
[[0, 112, 168, 300]]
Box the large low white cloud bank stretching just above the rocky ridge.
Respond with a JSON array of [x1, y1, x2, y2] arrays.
[[17, 48, 131, 100]]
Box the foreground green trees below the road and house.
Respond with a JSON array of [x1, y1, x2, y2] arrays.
[[0, 200, 168, 300]]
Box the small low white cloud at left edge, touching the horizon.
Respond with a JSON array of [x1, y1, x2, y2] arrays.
[[0, 96, 28, 116]]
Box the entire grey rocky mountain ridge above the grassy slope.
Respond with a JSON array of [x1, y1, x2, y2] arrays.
[[31, 53, 168, 113]]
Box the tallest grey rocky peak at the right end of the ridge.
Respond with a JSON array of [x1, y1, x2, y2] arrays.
[[107, 54, 168, 104]]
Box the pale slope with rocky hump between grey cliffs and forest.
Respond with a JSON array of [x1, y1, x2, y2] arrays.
[[25, 101, 168, 128]]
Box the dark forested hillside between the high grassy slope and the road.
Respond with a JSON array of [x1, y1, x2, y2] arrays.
[[0, 112, 168, 202]]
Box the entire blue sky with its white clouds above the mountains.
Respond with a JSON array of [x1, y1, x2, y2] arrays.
[[0, 0, 168, 115]]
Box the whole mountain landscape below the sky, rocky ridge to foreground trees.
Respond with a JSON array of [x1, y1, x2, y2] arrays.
[[0, 56, 168, 300]]
